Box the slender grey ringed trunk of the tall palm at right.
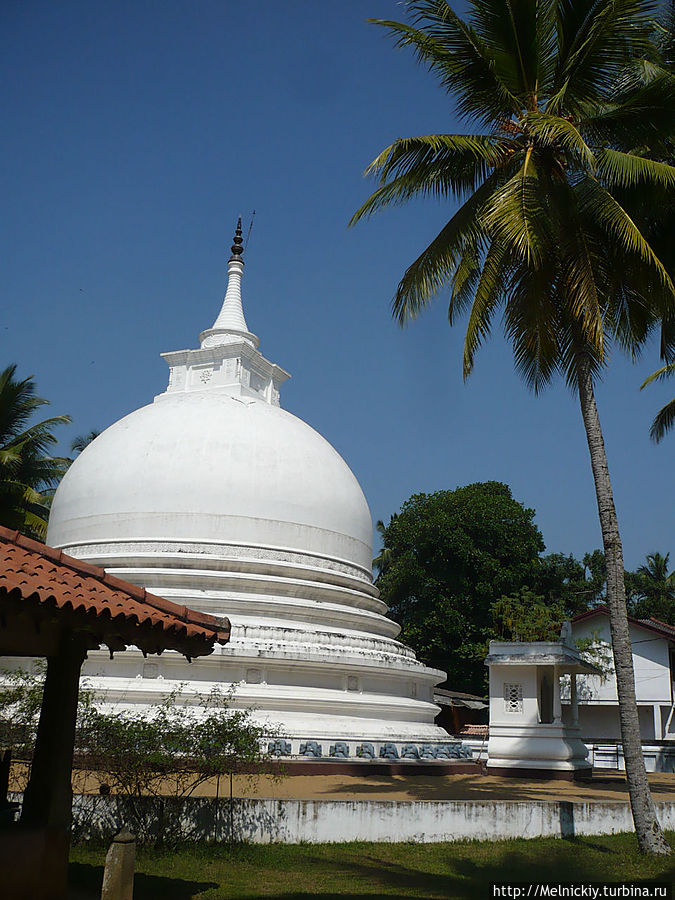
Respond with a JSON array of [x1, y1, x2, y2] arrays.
[[577, 353, 671, 855]]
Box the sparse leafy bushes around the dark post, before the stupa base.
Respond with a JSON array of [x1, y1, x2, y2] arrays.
[[0, 667, 270, 846]]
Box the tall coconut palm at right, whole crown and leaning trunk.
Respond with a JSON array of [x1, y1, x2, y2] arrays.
[[352, 0, 675, 854]]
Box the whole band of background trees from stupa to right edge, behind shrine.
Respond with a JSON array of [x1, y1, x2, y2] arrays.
[[373, 482, 675, 693]]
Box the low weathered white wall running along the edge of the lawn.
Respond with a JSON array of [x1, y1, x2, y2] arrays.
[[58, 796, 675, 844]]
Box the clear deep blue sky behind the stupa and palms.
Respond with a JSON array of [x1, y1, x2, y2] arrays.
[[0, 0, 675, 568]]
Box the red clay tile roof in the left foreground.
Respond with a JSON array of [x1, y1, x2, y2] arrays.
[[0, 526, 230, 656]]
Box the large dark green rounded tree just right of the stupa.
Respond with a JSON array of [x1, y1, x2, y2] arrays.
[[377, 481, 544, 693]]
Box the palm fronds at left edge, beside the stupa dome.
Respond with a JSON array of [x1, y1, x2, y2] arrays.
[[0, 365, 71, 539]]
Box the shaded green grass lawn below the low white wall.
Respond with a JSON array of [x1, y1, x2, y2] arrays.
[[70, 832, 675, 900]]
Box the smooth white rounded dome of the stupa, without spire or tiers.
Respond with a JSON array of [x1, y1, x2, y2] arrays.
[[49, 388, 372, 571]]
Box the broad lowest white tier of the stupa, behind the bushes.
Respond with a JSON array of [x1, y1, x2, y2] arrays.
[[82, 651, 448, 753]]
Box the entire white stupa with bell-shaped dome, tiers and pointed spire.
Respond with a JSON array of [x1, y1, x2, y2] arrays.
[[47, 220, 447, 752]]
